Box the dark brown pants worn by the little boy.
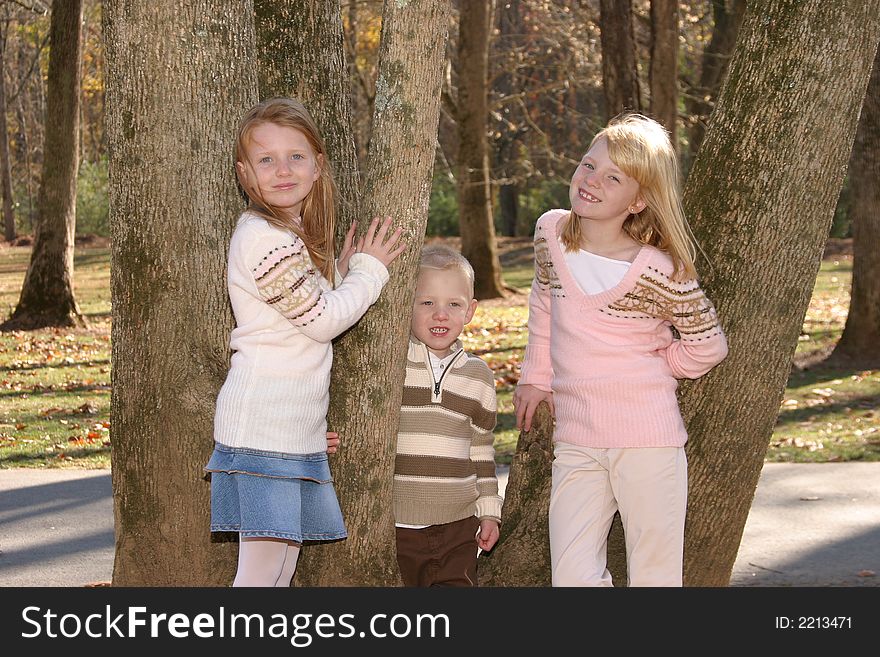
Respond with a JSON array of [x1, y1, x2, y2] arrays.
[[396, 516, 480, 586]]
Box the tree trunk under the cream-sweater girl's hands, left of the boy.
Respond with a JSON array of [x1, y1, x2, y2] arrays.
[[296, 0, 450, 586]]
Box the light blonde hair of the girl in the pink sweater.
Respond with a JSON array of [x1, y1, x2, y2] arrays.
[[560, 114, 697, 279]]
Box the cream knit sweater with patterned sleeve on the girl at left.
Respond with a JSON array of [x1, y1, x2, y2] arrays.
[[214, 212, 388, 454]]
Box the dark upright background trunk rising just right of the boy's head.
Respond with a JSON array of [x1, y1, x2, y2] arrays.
[[456, 2, 504, 299]]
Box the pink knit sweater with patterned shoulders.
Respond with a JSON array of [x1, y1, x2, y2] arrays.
[[519, 210, 727, 448]]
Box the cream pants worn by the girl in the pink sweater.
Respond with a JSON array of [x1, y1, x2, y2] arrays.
[[550, 443, 687, 586]]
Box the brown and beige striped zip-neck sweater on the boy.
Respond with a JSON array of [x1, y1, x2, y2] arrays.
[[394, 337, 502, 525]]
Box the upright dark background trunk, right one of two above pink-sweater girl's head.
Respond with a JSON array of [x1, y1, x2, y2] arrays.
[[650, 0, 678, 149]]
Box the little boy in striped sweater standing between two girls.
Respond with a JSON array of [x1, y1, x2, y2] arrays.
[[394, 245, 502, 586]]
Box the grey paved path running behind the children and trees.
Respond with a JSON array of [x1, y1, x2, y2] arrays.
[[0, 462, 880, 586]]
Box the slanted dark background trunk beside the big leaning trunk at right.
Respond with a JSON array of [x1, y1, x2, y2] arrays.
[[684, 0, 746, 170]]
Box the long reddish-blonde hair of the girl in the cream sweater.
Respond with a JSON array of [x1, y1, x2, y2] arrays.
[[234, 98, 336, 282]]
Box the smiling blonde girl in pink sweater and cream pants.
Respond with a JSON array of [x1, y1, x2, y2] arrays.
[[513, 114, 727, 586]]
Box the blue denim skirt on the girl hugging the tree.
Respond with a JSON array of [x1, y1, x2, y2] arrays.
[[205, 443, 348, 543]]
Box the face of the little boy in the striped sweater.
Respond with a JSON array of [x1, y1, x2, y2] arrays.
[[410, 267, 477, 358]]
